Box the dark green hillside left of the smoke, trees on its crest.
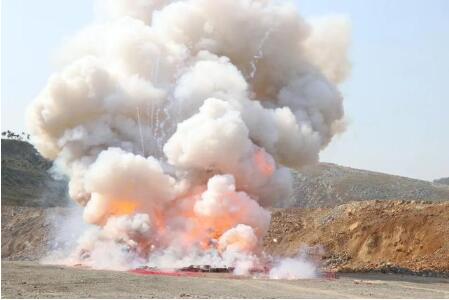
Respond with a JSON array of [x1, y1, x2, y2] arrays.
[[1, 139, 68, 207]]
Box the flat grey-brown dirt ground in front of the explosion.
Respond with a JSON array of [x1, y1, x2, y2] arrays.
[[2, 261, 449, 298]]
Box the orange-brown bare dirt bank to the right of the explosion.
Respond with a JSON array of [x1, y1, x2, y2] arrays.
[[264, 201, 449, 273]]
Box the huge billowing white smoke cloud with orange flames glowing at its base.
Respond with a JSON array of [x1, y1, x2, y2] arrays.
[[27, 0, 349, 273]]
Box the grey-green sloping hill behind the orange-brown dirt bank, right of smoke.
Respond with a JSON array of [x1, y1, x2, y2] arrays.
[[291, 163, 449, 207]]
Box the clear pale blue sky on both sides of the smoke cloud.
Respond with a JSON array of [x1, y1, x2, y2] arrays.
[[1, 0, 449, 180]]
